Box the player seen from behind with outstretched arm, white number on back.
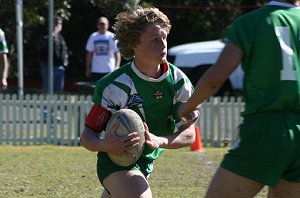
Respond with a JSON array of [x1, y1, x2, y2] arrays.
[[179, 0, 300, 198]]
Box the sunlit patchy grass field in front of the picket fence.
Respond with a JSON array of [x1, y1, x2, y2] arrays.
[[0, 146, 266, 198]]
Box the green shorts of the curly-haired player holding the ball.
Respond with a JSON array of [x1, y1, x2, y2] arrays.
[[97, 152, 154, 185]]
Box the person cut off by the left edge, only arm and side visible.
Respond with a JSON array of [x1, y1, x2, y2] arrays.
[[0, 29, 9, 90]]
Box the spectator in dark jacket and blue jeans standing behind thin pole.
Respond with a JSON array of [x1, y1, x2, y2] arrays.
[[41, 17, 69, 93]]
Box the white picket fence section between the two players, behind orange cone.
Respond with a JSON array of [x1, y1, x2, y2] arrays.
[[196, 97, 244, 147]]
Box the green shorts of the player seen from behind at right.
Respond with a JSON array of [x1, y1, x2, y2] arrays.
[[221, 112, 300, 187]]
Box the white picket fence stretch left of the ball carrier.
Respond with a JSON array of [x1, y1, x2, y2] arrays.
[[0, 94, 92, 145]]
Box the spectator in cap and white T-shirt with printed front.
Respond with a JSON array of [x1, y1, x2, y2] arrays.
[[85, 17, 121, 82]]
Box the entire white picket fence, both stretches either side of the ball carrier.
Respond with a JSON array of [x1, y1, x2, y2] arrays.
[[0, 94, 244, 147]]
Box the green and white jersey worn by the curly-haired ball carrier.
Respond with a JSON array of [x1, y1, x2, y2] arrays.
[[93, 62, 194, 159]]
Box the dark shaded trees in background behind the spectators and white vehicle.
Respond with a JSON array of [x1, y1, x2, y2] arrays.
[[0, 0, 264, 78]]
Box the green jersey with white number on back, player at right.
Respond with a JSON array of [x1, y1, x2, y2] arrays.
[[225, 1, 300, 115]]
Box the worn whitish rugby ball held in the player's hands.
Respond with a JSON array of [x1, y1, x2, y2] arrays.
[[105, 109, 145, 166]]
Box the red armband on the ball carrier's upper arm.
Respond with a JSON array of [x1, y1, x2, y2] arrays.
[[85, 105, 111, 133]]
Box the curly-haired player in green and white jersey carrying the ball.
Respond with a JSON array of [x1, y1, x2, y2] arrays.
[[80, 8, 198, 198]]
